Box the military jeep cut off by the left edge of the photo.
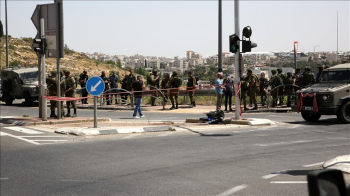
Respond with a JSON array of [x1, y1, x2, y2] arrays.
[[1, 68, 39, 106]]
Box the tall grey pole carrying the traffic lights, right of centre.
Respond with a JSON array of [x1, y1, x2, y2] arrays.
[[235, 0, 242, 120]]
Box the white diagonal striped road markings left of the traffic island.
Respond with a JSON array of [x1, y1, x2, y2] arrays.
[[0, 126, 76, 145]]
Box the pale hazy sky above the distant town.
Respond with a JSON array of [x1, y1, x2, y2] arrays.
[[0, 0, 350, 58]]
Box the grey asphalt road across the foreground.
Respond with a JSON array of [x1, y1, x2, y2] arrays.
[[0, 100, 350, 196]]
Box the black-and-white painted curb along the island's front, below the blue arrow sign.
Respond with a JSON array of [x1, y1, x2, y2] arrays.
[[55, 126, 175, 136]]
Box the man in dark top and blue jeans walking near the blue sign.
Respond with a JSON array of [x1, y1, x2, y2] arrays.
[[131, 75, 146, 118]]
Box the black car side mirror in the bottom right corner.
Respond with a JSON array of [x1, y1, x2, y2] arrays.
[[307, 169, 350, 196]]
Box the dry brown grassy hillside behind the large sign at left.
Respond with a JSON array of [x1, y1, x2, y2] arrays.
[[0, 37, 128, 77]]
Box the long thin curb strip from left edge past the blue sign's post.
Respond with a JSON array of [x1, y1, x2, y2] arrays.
[[0, 118, 112, 126]]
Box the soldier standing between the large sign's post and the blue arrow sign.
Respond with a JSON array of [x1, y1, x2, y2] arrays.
[[63, 69, 77, 117]]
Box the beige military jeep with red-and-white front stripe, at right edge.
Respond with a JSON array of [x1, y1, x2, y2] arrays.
[[292, 63, 350, 124]]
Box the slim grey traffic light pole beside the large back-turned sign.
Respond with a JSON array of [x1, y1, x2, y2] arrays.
[[39, 18, 47, 121]]
